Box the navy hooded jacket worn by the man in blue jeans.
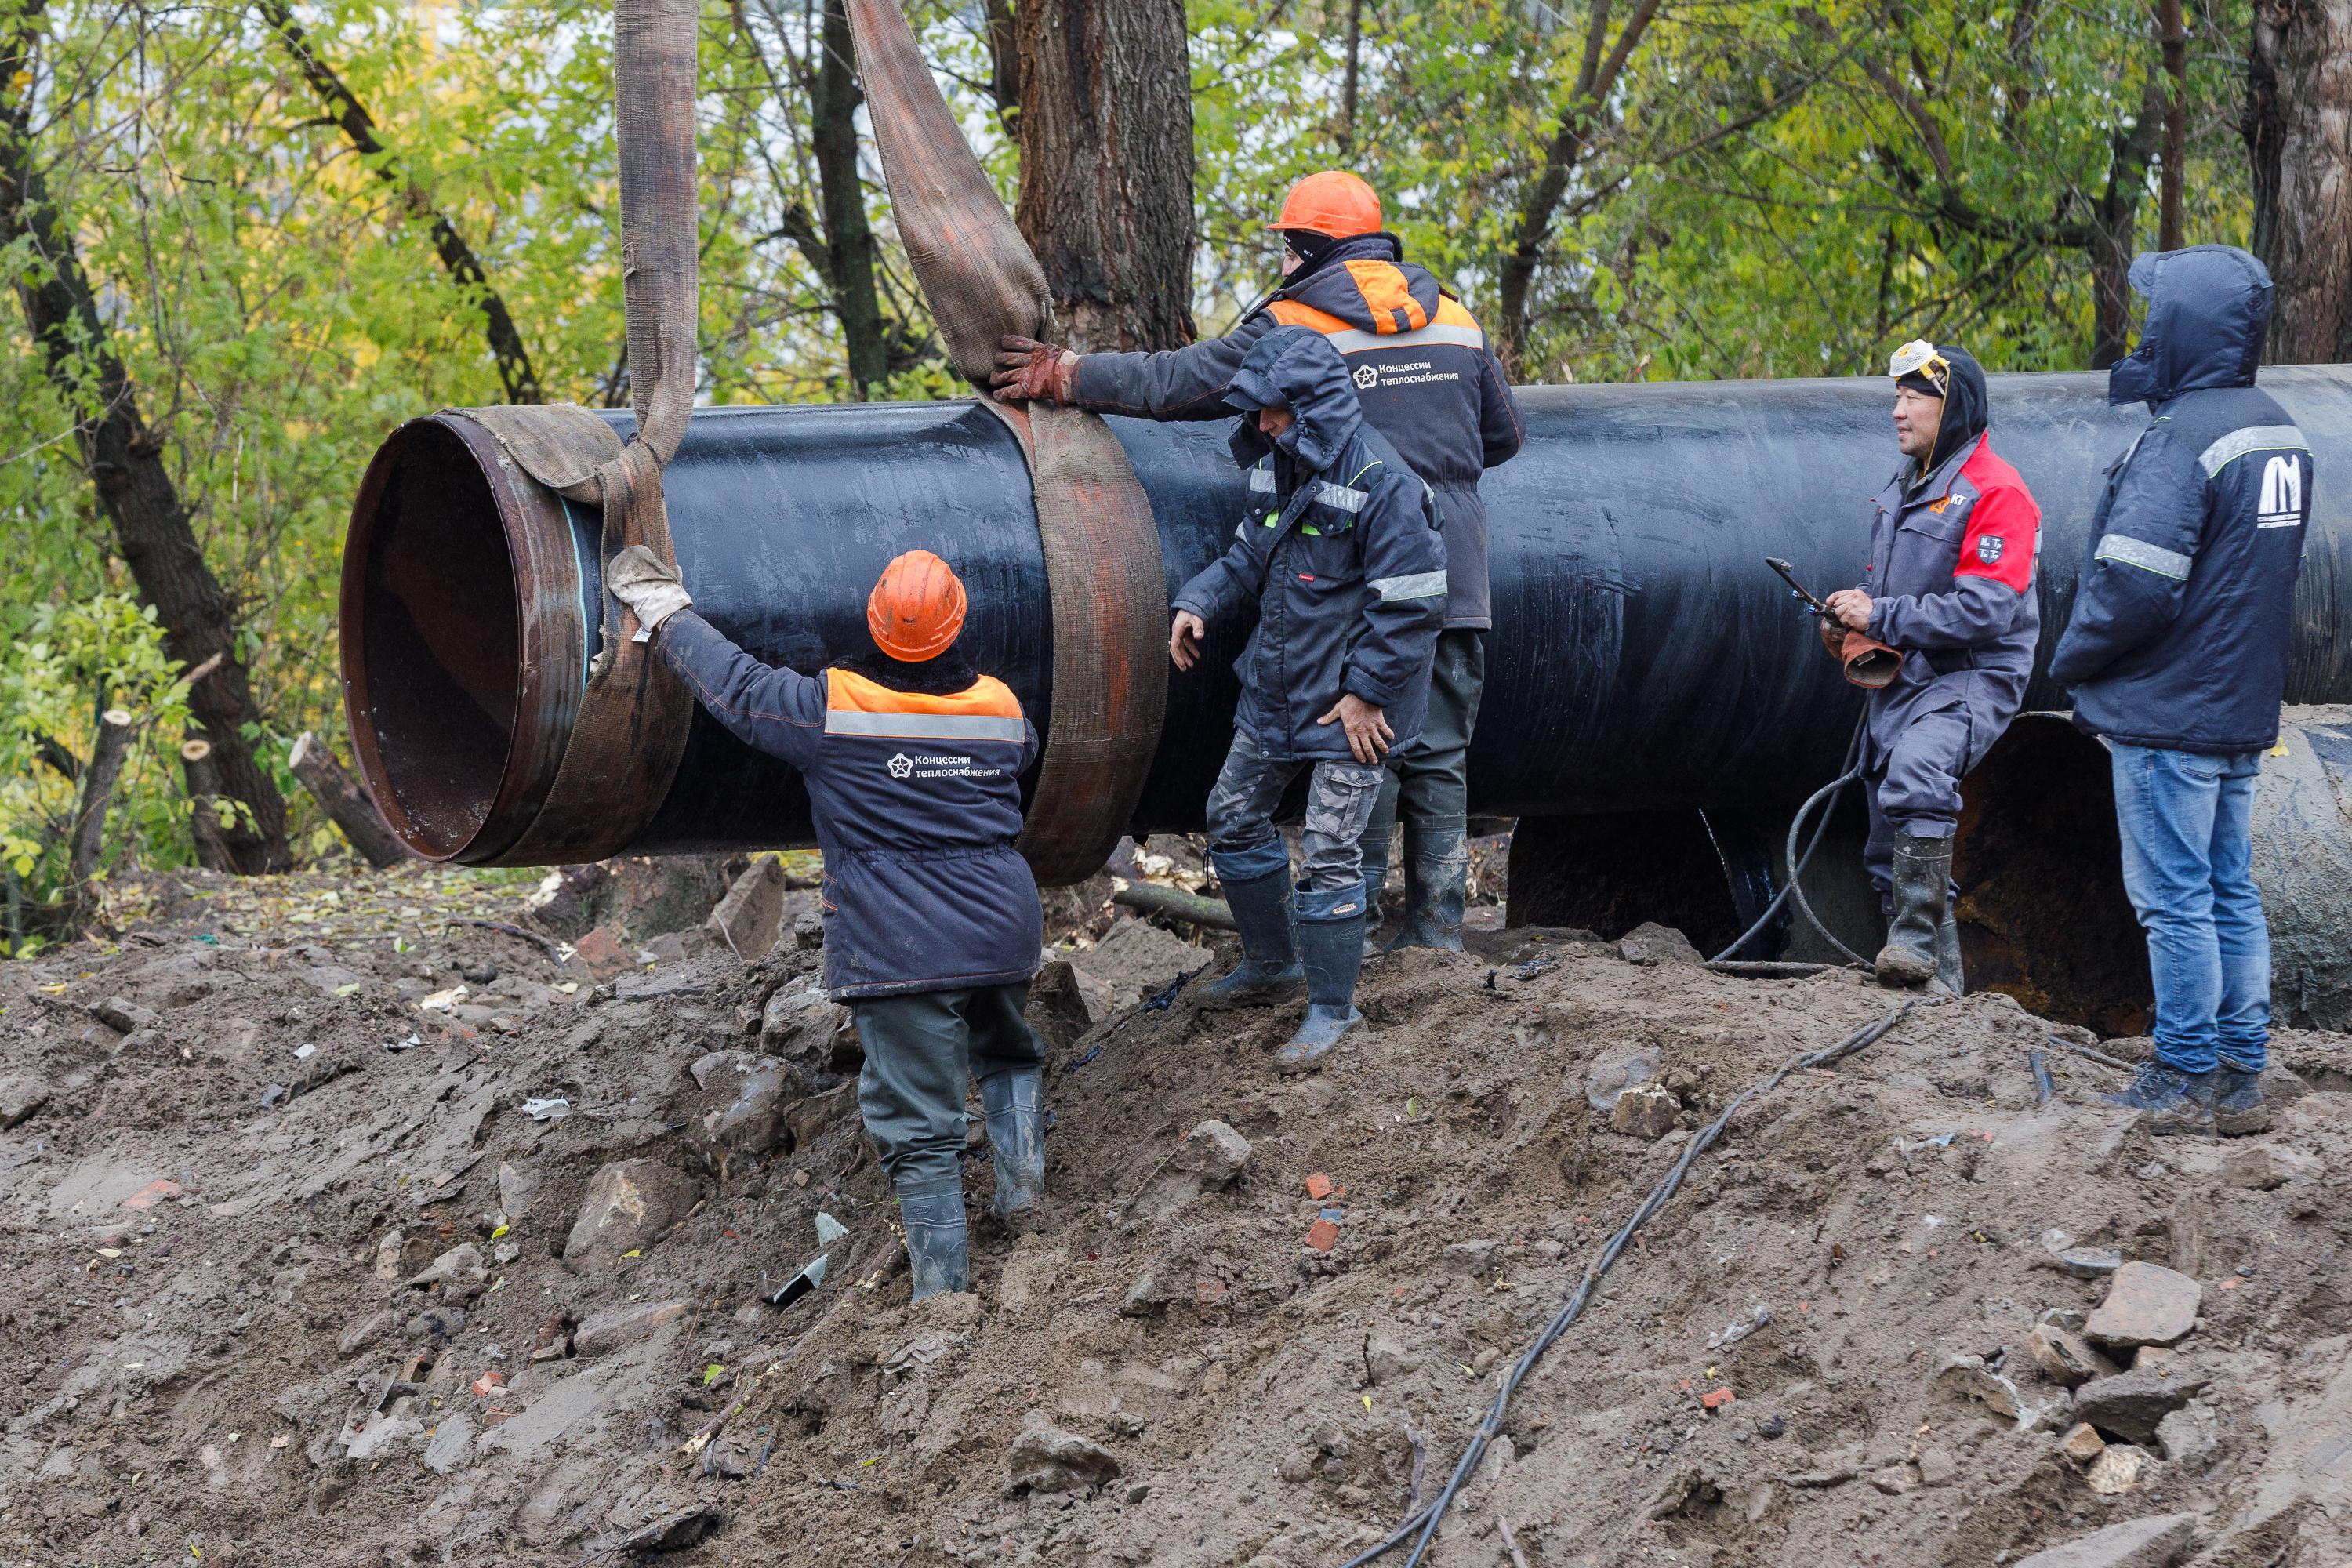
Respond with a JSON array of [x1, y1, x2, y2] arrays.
[[2051, 245, 2312, 755]]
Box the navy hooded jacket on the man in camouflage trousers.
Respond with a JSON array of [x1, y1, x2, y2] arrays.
[[1176, 327, 1446, 760]]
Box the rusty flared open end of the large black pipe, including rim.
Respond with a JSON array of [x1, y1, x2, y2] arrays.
[[341, 412, 595, 865]]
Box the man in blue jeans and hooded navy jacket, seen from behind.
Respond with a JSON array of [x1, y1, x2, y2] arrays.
[[2051, 245, 2312, 1135]]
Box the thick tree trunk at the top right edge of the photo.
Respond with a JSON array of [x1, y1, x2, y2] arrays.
[[2244, 0, 2352, 365]]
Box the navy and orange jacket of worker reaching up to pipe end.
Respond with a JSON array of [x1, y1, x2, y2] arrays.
[[659, 609, 1044, 1001]]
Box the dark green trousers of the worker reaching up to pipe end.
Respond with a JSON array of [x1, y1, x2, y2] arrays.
[[849, 980, 1044, 1192]]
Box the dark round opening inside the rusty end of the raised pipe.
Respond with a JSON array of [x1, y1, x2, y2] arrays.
[[343, 421, 524, 860]]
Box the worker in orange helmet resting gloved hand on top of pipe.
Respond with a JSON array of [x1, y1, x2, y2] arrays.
[[995, 169, 1526, 947]]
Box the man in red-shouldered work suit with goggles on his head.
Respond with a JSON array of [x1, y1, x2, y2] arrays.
[[1820, 343, 2042, 996]]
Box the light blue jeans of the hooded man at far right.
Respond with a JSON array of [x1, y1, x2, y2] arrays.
[[2110, 743, 2270, 1074]]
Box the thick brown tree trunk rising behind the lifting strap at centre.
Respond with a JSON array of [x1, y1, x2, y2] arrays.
[[1014, 0, 1192, 350]]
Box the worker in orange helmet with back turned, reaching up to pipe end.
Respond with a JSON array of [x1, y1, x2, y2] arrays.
[[604, 546, 1044, 1300]]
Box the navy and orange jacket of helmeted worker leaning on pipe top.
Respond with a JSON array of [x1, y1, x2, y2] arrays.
[[1077, 235, 1526, 628]]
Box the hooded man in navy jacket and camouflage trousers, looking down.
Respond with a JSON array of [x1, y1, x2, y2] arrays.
[[1169, 327, 1446, 1072]]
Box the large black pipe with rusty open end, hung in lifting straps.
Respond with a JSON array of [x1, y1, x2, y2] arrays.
[[343, 367, 2352, 862]]
